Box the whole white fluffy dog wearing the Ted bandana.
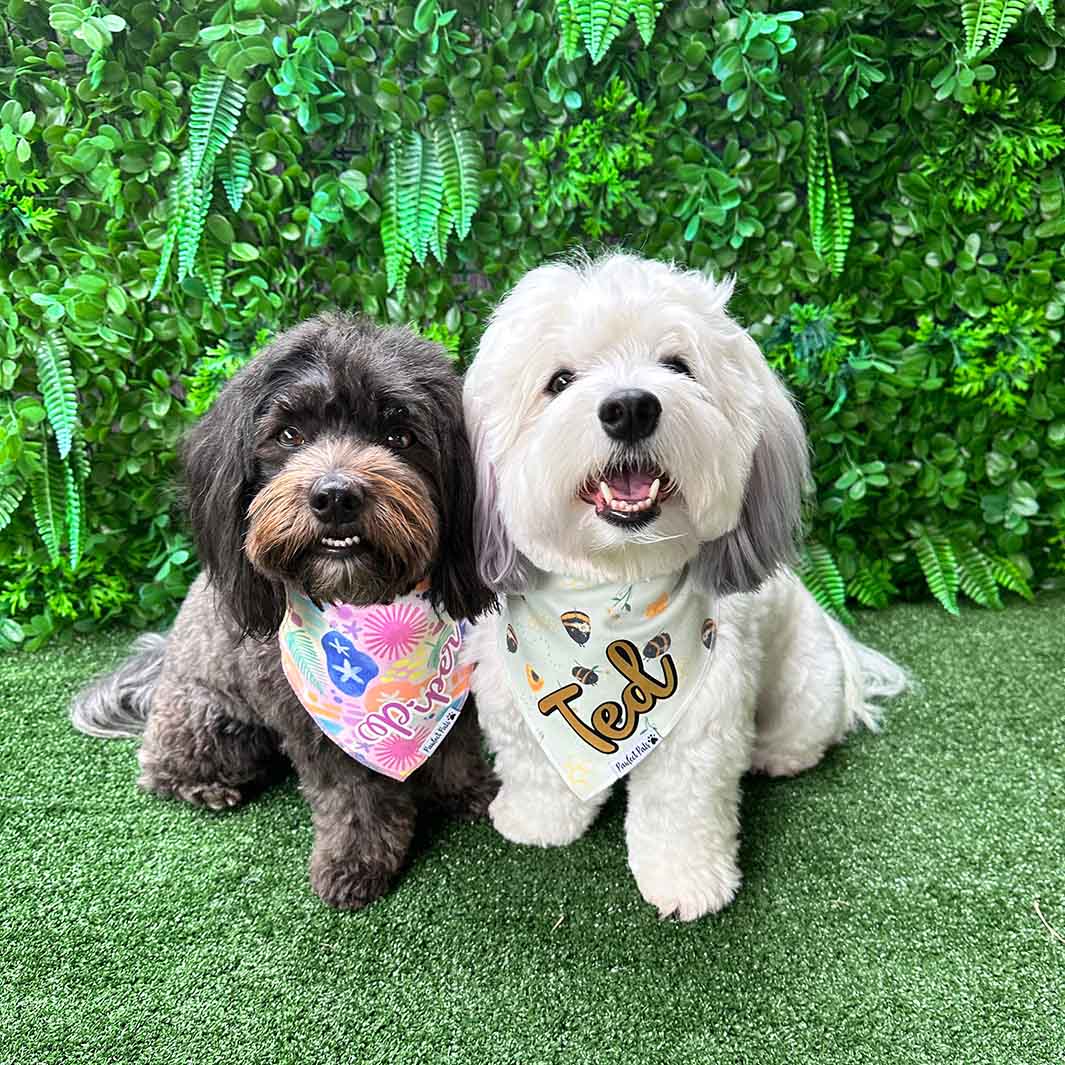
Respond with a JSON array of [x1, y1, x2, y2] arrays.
[[464, 255, 906, 920]]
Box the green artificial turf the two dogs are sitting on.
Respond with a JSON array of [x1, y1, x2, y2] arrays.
[[0, 596, 1065, 1065]]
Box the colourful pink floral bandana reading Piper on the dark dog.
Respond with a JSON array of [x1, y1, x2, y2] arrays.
[[278, 587, 473, 781]]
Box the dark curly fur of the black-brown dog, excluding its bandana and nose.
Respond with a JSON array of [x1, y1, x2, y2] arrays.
[[71, 315, 495, 908]]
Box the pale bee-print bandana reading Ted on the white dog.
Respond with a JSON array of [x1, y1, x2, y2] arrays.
[[497, 569, 717, 799]]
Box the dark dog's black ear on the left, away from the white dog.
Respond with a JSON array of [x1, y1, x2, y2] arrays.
[[182, 356, 284, 636]]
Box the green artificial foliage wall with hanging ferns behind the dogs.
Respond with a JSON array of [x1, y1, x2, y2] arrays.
[[0, 0, 1065, 645]]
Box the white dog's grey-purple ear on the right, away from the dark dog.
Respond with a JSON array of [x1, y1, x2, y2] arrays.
[[695, 333, 809, 594]]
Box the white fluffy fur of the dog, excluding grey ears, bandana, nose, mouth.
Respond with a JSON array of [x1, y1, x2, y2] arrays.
[[465, 255, 906, 920]]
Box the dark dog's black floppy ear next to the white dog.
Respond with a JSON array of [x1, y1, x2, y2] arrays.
[[421, 380, 495, 618]]
